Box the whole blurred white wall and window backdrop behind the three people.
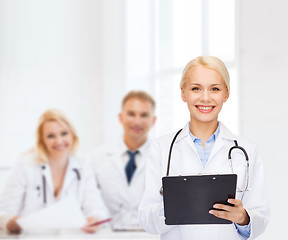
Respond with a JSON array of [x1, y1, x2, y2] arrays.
[[0, 0, 288, 239]]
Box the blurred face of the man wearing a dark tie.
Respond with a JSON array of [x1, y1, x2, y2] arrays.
[[119, 98, 156, 140]]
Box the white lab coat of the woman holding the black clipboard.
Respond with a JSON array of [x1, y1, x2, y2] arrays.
[[139, 123, 269, 240]]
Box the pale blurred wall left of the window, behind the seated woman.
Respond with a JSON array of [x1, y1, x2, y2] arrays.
[[0, 0, 126, 166]]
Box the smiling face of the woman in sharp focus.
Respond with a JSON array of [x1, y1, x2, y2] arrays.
[[181, 66, 229, 123]]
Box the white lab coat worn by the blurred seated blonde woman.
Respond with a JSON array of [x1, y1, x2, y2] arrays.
[[0, 152, 109, 230]]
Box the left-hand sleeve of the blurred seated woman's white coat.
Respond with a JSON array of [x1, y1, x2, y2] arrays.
[[0, 161, 27, 231]]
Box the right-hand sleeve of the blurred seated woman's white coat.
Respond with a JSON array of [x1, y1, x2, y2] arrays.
[[82, 166, 109, 220]]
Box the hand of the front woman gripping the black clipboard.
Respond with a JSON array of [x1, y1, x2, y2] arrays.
[[209, 199, 250, 226]]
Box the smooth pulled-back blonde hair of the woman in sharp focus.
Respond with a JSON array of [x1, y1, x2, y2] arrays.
[[180, 56, 230, 92]]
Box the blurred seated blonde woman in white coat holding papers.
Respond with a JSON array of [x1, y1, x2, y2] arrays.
[[0, 110, 108, 233]]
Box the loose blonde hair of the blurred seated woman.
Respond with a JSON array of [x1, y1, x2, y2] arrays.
[[35, 109, 79, 163]]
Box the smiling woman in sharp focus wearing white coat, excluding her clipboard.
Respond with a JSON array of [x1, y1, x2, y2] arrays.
[[139, 56, 269, 240]]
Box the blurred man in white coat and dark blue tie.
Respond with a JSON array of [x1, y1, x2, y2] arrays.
[[88, 91, 156, 230]]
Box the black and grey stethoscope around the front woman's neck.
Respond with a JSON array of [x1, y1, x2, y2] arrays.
[[160, 129, 249, 196]]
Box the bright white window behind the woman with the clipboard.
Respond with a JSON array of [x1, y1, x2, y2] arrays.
[[125, 0, 238, 136]]
